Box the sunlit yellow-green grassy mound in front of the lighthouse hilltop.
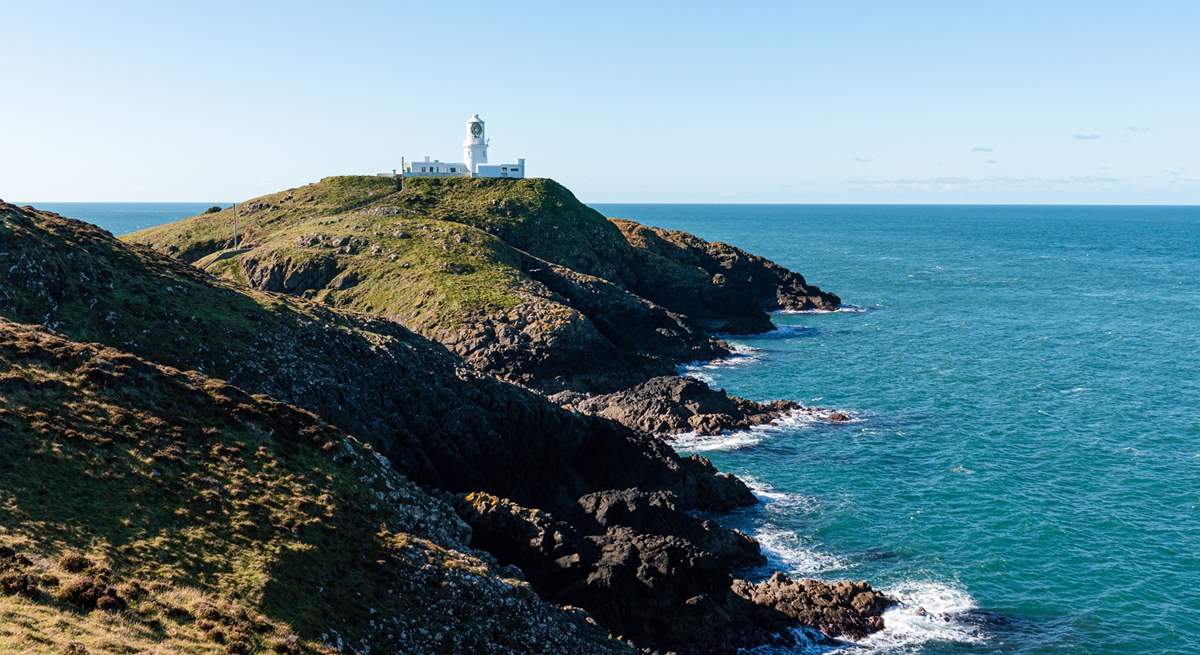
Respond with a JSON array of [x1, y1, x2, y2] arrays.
[[197, 205, 549, 337]]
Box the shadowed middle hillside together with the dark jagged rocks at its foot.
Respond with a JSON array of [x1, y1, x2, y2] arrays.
[[0, 204, 892, 654]]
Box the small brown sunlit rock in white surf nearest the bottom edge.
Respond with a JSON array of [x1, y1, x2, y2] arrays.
[[733, 573, 894, 639]]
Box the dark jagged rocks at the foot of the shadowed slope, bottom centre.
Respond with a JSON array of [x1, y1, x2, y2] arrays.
[[458, 489, 775, 654]]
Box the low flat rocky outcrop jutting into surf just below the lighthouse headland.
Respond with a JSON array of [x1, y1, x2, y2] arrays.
[[552, 375, 802, 434]]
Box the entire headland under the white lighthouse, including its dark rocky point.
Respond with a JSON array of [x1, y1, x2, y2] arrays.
[[126, 178, 839, 393]]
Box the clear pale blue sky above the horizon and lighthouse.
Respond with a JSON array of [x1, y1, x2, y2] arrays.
[[0, 0, 1200, 204]]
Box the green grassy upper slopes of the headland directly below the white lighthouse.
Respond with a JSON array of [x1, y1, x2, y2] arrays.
[[124, 176, 628, 330]]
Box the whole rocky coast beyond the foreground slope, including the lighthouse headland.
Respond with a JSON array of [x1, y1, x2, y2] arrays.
[[0, 179, 889, 655]]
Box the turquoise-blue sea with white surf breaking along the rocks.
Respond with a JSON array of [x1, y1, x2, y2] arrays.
[[21, 203, 1200, 655]]
